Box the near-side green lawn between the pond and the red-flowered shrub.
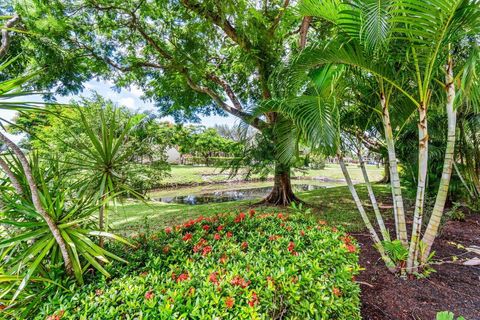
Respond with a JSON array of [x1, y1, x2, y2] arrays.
[[109, 185, 391, 235]]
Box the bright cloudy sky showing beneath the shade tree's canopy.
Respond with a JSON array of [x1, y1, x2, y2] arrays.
[[0, 80, 239, 141]]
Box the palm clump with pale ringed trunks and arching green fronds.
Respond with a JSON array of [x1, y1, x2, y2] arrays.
[[278, 0, 480, 273]]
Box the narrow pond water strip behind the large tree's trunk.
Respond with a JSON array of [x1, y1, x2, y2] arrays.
[[151, 184, 327, 205]]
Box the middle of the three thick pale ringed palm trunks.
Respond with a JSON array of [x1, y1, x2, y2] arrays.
[[407, 101, 428, 273]]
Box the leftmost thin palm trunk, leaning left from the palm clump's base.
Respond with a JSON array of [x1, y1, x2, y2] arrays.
[[337, 151, 395, 272]]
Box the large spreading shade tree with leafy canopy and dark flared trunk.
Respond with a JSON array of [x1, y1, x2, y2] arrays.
[[5, 0, 327, 204]]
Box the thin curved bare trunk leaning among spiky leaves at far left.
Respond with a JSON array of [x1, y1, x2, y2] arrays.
[[0, 132, 73, 275]]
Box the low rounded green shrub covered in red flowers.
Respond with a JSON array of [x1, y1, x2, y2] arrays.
[[38, 210, 360, 319]]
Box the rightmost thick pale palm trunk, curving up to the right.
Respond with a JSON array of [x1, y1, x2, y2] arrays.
[[421, 59, 457, 262]]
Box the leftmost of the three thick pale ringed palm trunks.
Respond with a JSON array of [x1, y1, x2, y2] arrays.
[[380, 93, 408, 247]]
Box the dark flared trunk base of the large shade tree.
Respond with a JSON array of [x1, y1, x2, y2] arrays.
[[262, 163, 302, 206]]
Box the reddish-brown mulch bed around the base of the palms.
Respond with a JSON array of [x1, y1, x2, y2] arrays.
[[353, 214, 480, 320]]
